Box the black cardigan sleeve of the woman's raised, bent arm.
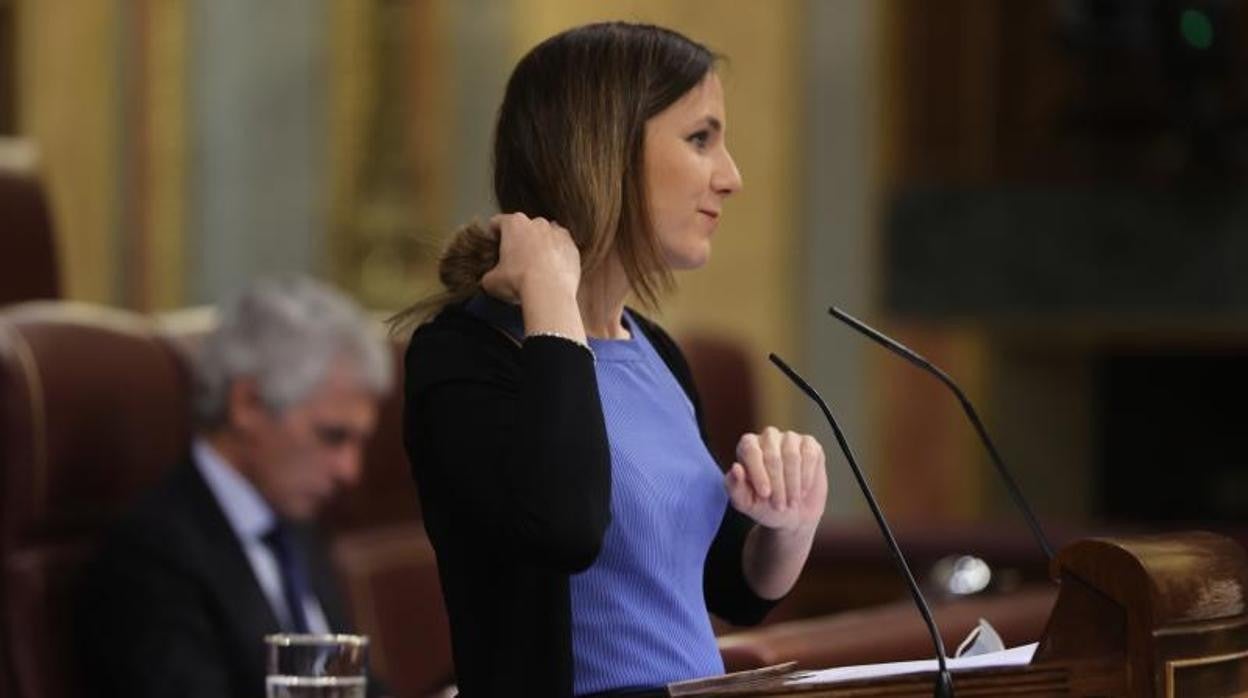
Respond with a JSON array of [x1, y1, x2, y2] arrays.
[[404, 320, 610, 572]]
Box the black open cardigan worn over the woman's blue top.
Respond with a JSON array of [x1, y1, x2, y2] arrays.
[[404, 306, 774, 697]]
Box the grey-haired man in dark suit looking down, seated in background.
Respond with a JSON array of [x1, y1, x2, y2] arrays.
[[77, 277, 392, 698]]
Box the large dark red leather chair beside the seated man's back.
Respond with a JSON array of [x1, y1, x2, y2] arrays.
[[0, 302, 188, 698]]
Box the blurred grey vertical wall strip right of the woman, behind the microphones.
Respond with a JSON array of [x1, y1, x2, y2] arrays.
[[790, 0, 889, 518]]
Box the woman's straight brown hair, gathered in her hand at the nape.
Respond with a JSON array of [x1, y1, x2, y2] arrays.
[[391, 22, 716, 327]]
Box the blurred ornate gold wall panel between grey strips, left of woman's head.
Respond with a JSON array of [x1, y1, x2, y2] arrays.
[[328, 0, 456, 308]]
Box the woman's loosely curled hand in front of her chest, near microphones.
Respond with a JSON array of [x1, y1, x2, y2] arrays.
[[724, 427, 827, 533]]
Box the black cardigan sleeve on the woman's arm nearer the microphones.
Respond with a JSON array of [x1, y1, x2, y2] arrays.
[[631, 312, 784, 626]]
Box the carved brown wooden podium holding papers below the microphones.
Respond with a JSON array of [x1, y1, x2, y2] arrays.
[[698, 532, 1248, 698]]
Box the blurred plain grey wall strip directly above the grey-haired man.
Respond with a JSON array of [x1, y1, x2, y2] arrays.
[[185, 0, 331, 303]]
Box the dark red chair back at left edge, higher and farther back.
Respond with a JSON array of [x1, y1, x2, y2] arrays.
[[0, 139, 60, 306]]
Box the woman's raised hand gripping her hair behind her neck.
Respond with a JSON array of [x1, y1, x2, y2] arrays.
[[480, 214, 580, 305]]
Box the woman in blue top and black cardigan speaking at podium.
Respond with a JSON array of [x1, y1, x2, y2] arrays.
[[401, 22, 827, 697]]
